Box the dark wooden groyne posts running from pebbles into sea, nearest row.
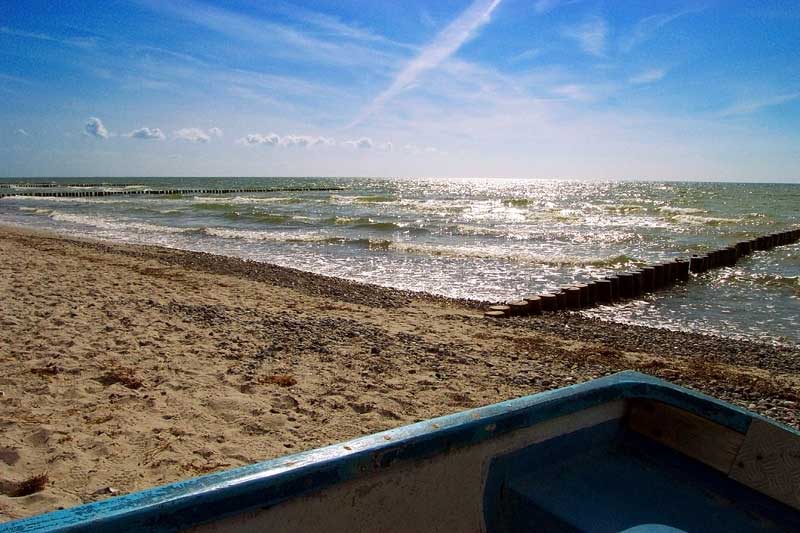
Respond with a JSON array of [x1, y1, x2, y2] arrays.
[[484, 228, 800, 318]]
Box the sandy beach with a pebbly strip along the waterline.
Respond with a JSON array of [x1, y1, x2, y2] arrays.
[[0, 227, 800, 521]]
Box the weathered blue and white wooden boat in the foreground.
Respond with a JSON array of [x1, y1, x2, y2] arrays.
[[0, 372, 800, 532]]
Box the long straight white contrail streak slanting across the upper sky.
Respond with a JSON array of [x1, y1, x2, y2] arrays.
[[350, 0, 502, 127]]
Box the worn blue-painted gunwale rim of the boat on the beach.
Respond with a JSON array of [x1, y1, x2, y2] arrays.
[[0, 371, 788, 532]]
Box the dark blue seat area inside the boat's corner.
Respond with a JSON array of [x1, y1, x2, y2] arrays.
[[486, 421, 800, 533]]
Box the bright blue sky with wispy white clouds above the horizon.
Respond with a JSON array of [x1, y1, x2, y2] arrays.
[[0, 0, 800, 181]]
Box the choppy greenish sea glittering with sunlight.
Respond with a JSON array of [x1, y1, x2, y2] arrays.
[[0, 177, 800, 346]]
